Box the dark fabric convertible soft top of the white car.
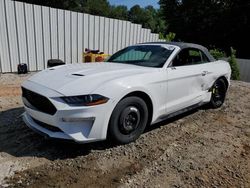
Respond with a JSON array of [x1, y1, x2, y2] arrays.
[[143, 42, 215, 61]]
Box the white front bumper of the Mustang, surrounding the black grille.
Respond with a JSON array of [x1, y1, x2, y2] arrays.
[[23, 80, 114, 143]]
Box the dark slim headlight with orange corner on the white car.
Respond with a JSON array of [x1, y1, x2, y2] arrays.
[[61, 94, 109, 106]]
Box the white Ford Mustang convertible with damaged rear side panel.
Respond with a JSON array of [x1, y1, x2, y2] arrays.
[[22, 43, 231, 144]]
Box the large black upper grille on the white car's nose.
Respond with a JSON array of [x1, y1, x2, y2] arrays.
[[22, 87, 56, 115]]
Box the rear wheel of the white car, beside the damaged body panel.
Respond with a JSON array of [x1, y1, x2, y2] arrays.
[[209, 79, 227, 109]]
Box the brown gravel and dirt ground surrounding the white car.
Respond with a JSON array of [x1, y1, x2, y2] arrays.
[[0, 74, 250, 187]]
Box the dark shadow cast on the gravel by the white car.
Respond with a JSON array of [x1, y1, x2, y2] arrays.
[[0, 108, 201, 160]]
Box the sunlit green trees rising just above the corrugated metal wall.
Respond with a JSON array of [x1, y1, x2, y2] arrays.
[[16, 0, 166, 34]]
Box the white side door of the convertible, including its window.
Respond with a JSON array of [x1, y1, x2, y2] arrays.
[[167, 48, 207, 114]]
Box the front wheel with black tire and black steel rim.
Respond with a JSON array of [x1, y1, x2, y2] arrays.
[[108, 97, 148, 144]]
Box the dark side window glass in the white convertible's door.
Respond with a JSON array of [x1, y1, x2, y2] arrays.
[[172, 48, 209, 67]]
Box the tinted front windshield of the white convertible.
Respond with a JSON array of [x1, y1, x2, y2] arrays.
[[108, 45, 173, 68]]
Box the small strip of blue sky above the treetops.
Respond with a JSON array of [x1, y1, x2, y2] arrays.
[[109, 0, 160, 8]]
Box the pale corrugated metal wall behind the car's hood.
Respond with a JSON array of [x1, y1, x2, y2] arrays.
[[0, 0, 164, 73]]
